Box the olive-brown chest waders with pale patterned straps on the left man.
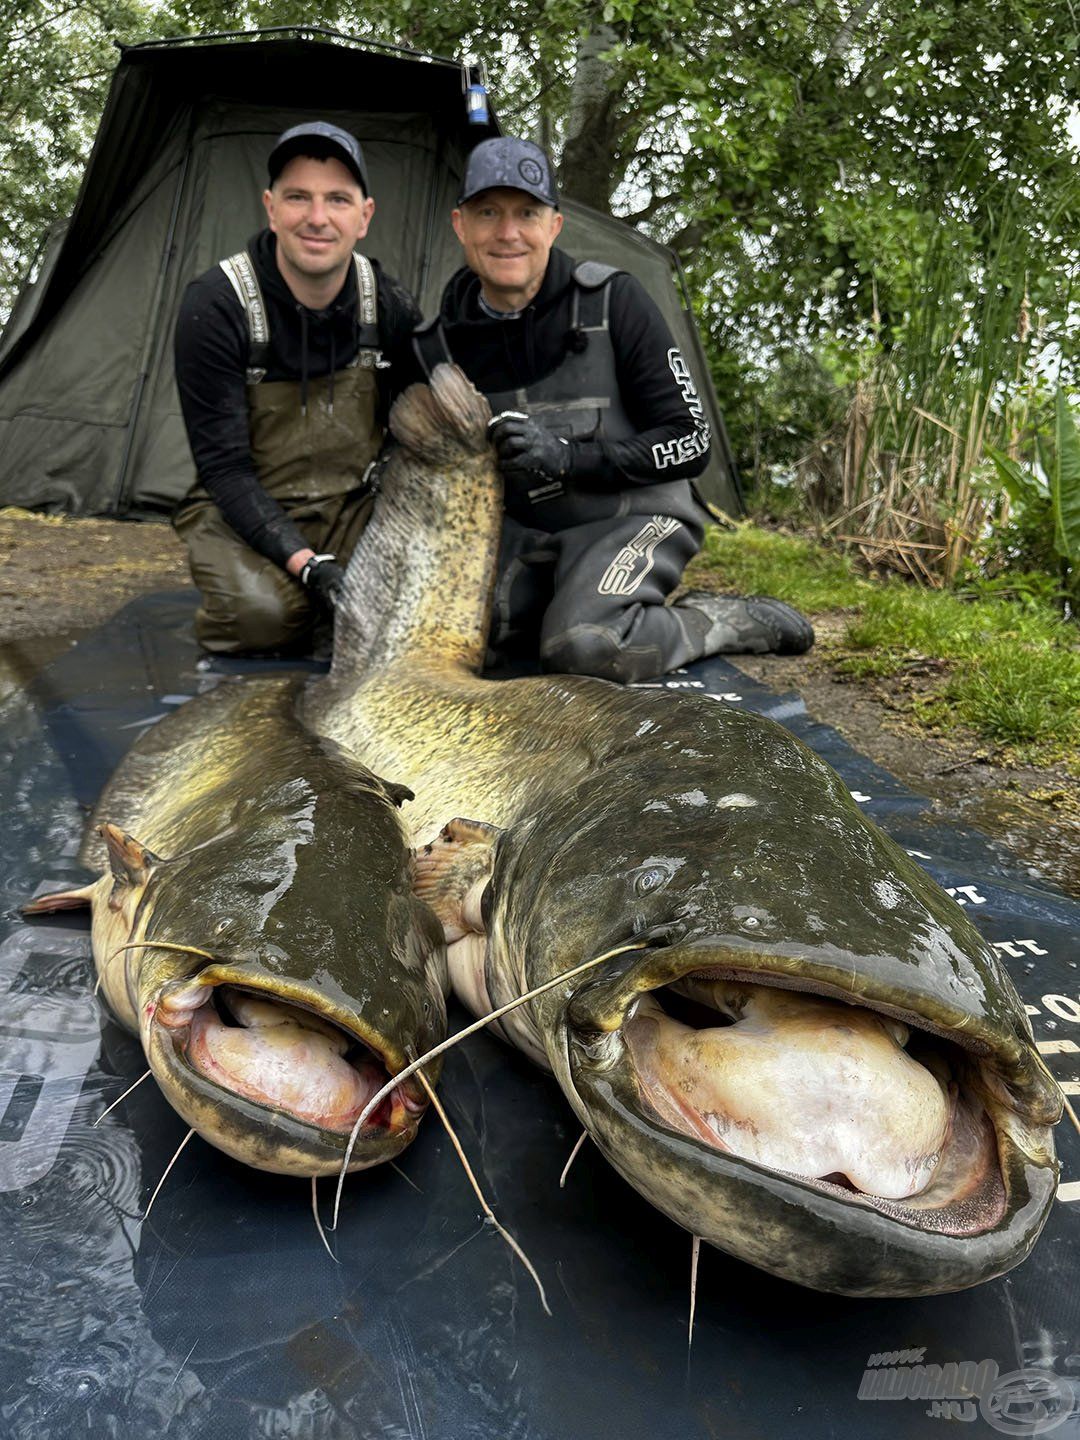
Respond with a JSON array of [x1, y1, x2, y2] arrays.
[[173, 251, 383, 654]]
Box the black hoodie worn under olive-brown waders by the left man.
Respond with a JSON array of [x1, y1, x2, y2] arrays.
[[176, 230, 420, 566]]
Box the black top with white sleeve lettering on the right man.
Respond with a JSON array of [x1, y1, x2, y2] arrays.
[[439, 248, 708, 488]]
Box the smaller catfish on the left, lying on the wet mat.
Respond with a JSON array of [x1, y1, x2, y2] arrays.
[[26, 677, 446, 1175]]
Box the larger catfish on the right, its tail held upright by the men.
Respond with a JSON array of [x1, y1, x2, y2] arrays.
[[304, 367, 1061, 1295]]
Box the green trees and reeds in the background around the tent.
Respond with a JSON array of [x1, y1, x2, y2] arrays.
[[0, 0, 1080, 610]]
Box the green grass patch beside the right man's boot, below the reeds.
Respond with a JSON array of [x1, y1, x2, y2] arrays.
[[685, 523, 1080, 775]]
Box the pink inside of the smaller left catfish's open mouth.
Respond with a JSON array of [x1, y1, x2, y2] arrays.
[[154, 976, 426, 1136]]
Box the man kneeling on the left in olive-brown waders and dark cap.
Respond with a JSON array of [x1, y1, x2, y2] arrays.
[[173, 121, 419, 654]]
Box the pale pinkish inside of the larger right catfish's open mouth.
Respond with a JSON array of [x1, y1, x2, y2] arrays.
[[621, 971, 1007, 1236]]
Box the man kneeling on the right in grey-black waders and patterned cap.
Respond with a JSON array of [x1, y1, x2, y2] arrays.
[[415, 137, 814, 683]]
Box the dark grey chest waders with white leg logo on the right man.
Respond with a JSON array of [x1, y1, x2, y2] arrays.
[[415, 261, 707, 684]]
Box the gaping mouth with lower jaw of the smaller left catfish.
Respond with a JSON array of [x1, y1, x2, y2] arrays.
[[144, 976, 428, 1174]]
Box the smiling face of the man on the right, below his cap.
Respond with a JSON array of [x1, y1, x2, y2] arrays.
[[452, 187, 563, 310]]
